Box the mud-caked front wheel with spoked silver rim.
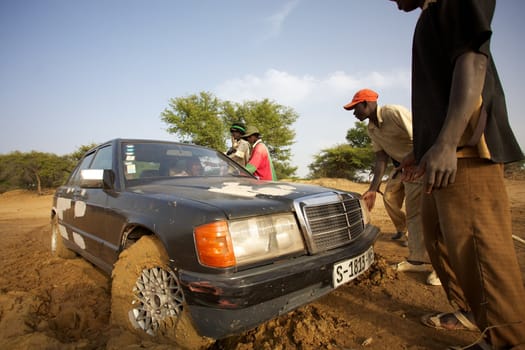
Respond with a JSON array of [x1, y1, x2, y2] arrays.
[[111, 236, 212, 349]]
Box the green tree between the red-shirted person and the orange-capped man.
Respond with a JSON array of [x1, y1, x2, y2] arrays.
[[308, 122, 374, 181]]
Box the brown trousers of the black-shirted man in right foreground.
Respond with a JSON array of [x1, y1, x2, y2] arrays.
[[422, 158, 525, 348]]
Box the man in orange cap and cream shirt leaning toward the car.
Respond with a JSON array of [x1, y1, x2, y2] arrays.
[[344, 89, 439, 285]]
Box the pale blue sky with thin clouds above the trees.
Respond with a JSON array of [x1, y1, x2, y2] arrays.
[[0, 0, 525, 176]]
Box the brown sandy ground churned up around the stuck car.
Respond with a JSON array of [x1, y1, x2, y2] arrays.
[[0, 179, 525, 350]]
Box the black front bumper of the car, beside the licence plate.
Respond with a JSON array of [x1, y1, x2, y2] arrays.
[[179, 221, 379, 339]]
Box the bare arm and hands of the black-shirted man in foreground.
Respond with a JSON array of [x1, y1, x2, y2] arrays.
[[399, 51, 487, 193]]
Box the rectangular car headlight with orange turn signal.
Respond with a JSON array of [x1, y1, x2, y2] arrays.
[[195, 214, 304, 267]]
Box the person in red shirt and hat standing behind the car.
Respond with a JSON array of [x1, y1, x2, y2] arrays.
[[242, 126, 277, 181]]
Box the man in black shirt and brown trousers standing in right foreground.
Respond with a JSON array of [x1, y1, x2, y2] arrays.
[[388, 0, 525, 349]]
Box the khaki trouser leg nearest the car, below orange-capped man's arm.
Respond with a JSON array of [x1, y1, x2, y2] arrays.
[[383, 169, 407, 232]]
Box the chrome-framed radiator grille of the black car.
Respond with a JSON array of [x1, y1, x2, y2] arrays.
[[298, 194, 364, 254]]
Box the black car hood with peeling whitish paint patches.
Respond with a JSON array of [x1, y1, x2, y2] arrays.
[[128, 177, 357, 218]]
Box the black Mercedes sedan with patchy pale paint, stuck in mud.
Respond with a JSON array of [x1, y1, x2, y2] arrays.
[[51, 139, 379, 348]]
